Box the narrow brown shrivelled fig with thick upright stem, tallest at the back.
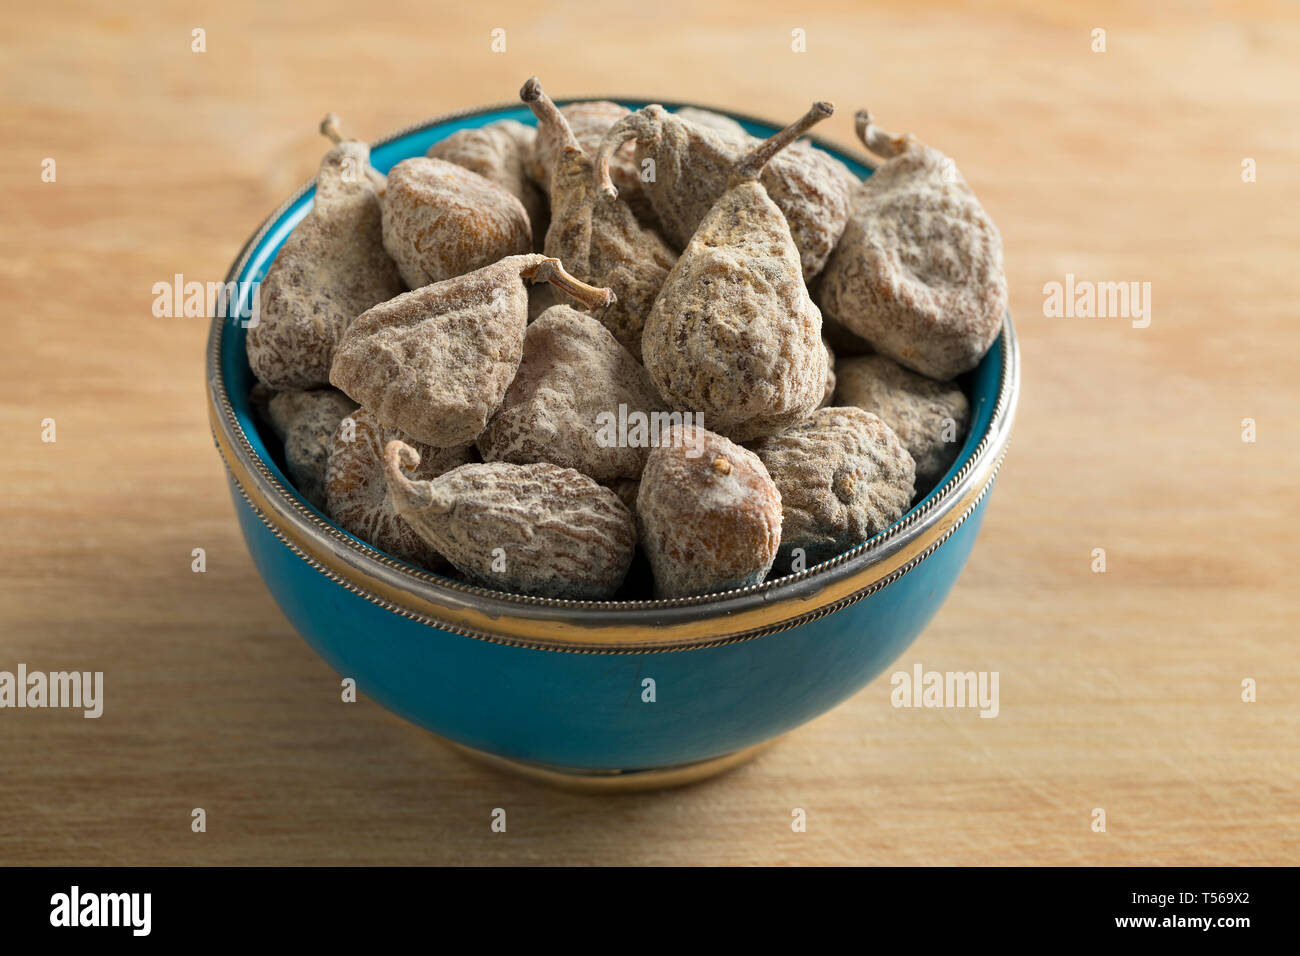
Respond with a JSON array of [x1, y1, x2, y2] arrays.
[[519, 77, 677, 360]]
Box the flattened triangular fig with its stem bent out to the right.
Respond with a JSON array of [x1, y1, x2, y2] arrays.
[[330, 254, 614, 447]]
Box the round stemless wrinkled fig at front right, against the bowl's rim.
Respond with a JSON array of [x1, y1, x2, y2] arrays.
[[753, 407, 915, 575]]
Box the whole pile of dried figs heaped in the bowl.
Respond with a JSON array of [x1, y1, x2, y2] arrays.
[[247, 78, 1006, 601]]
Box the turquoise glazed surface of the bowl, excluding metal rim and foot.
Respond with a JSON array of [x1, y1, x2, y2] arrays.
[[210, 103, 1009, 770]]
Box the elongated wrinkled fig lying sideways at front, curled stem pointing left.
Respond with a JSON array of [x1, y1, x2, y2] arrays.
[[385, 442, 636, 601]]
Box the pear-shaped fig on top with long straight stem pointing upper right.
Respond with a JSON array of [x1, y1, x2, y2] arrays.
[[639, 103, 832, 441]]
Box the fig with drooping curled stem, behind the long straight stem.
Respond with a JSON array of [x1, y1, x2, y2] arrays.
[[595, 104, 855, 280]]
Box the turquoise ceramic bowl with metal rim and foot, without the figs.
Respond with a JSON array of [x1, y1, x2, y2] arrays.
[[208, 101, 1019, 787]]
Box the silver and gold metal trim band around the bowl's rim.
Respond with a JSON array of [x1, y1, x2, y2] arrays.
[[207, 98, 1019, 653]]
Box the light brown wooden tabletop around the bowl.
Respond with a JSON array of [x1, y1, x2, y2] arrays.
[[0, 0, 1300, 864]]
